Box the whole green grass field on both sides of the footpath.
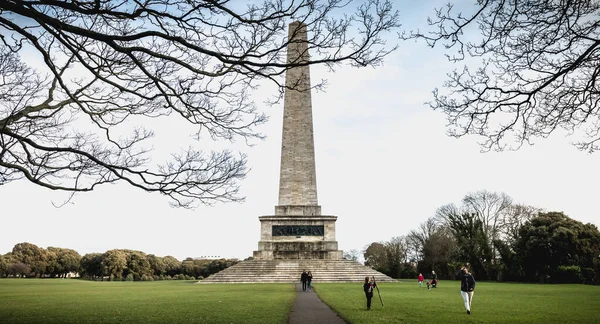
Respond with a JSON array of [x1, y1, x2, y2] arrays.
[[0, 279, 600, 324]]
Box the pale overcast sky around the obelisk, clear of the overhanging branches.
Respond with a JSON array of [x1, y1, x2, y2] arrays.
[[0, 1, 600, 260]]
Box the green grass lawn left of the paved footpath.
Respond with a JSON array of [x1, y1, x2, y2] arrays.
[[0, 279, 296, 324]]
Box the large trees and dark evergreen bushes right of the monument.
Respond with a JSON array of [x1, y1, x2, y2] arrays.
[[363, 190, 600, 284]]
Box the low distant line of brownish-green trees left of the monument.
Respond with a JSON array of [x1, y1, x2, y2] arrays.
[[0, 243, 238, 281]]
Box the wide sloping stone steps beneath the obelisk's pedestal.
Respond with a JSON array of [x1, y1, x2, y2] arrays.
[[199, 260, 396, 283]]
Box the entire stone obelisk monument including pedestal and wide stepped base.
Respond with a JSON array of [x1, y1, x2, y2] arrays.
[[200, 22, 395, 284]]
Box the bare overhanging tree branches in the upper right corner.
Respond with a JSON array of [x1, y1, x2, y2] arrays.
[[404, 0, 600, 152]]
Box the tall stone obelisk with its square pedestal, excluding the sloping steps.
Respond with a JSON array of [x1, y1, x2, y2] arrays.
[[254, 22, 342, 260]]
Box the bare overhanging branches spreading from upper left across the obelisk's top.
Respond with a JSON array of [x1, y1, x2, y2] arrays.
[[0, 0, 398, 207]]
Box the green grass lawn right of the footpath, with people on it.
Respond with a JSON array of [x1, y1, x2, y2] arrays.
[[314, 280, 600, 324]]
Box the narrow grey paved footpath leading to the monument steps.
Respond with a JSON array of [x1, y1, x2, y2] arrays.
[[290, 283, 346, 324]]
